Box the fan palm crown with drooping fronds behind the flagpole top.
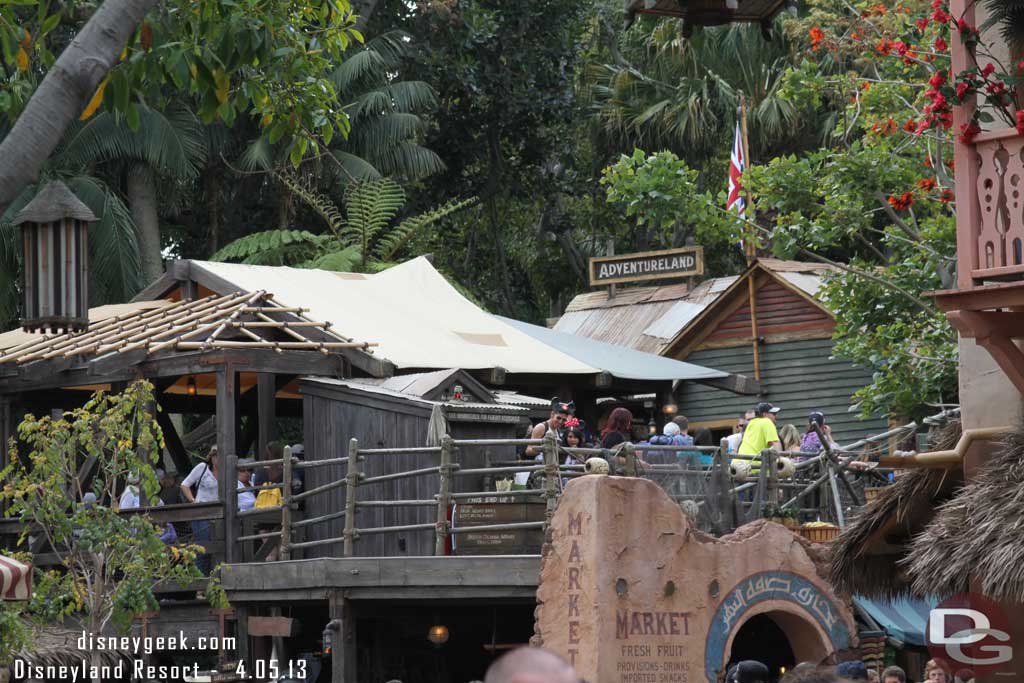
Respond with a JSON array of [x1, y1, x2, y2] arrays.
[[592, 18, 834, 168]]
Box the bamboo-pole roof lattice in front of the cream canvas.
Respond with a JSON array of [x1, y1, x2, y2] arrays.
[[0, 290, 375, 366]]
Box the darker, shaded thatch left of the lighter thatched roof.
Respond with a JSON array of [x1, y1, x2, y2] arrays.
[[829, 422, 964, 598]]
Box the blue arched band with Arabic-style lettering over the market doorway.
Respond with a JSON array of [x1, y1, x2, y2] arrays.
[[705, 571, 850, 681]]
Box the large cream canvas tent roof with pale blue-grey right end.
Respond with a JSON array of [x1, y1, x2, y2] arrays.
[[190, 257, 727, 380]]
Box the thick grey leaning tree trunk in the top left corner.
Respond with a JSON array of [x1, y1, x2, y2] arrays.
[[0, 0, 157, 213]]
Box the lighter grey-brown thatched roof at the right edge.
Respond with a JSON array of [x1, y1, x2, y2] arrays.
[[901, 425, 1024, 603]]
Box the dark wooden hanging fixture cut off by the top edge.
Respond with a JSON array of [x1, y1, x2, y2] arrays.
[[625, 0, 797, 38]]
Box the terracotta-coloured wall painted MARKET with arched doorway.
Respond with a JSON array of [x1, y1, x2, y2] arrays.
[[535, 476, 856, 683]]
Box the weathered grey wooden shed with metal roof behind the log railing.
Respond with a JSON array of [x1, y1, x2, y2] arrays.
[[299, 370, 529, 557]]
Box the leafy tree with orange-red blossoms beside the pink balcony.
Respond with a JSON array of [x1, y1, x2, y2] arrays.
[[744, 0, 956, 416]]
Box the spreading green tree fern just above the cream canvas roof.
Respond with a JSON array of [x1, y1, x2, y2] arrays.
[[211, 175, 472, 272]]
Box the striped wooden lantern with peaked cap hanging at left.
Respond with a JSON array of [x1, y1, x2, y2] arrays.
[[14, 180, 96, 332]]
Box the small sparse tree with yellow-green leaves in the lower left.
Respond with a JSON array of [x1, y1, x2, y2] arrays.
[[0, 382, 200, 634]]
